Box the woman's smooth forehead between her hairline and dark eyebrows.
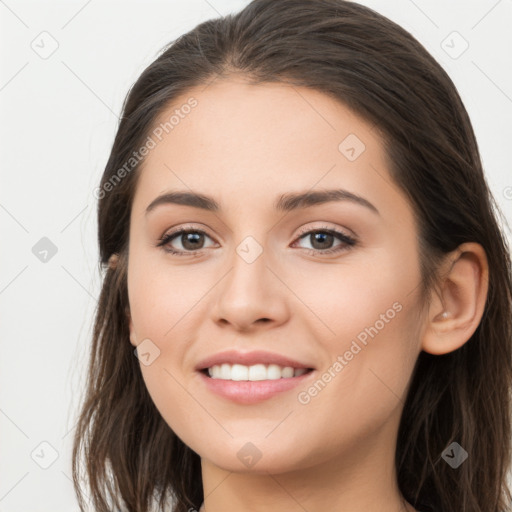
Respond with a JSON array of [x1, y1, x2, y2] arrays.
[[134, 78, 406, 222]]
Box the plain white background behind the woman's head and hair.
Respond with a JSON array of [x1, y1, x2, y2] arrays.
[[0, 0, 512, 512]]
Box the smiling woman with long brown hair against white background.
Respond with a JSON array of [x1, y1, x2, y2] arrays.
[[73, 0, 512, 512]]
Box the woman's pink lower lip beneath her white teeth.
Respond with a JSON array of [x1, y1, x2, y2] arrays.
[[198, 370, 314, 404]]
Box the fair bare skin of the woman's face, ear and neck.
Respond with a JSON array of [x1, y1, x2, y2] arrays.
[[128, 77, 488, 512]]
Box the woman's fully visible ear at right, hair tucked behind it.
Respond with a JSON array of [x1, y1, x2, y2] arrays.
[[421, 242, 489, 355]]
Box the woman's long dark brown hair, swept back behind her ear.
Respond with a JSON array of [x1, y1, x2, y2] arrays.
[[73, 0, 512, 512]]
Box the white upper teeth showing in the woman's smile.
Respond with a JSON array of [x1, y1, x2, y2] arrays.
[[208, 363, 307, 381]]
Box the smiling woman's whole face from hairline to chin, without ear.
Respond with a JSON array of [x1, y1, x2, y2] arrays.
[[128, 80, 421, 473]]
